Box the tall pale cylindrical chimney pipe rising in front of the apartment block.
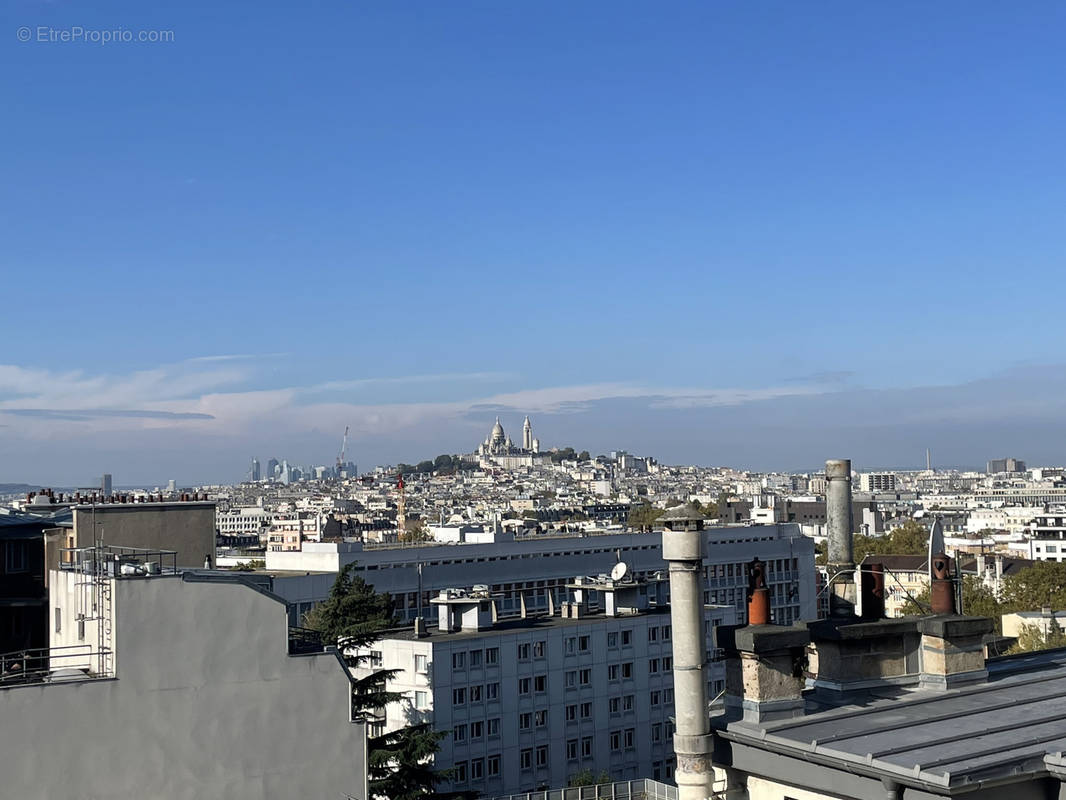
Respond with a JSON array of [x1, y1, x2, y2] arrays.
[[662, 507, 714, 800]]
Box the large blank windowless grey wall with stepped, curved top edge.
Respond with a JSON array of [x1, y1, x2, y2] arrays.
[[0, 577, 366, 800]]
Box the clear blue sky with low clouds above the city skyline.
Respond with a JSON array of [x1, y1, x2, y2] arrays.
[[0, 0, 1066, 483]]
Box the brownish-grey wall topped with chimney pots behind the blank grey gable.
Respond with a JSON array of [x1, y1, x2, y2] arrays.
[[74, 502, 215, 567]]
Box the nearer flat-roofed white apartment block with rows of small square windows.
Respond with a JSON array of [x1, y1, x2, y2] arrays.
[[356, 579, 736, 797]]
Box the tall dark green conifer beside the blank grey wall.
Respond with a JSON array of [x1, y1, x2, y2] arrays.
[[304, 563, 446, 800]]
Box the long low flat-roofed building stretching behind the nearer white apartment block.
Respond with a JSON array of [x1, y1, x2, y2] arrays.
[[267, 523, 819, 625]]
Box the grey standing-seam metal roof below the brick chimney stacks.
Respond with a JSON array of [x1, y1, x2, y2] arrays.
[[714, 649, 1066, 794]]
